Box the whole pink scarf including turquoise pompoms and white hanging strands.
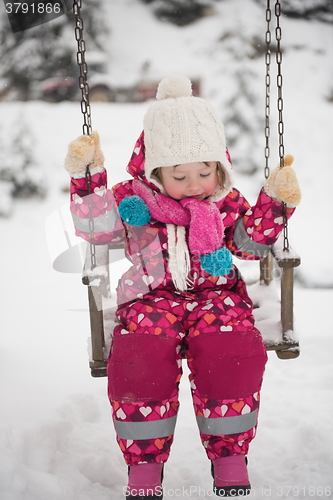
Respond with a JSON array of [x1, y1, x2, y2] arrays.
[[118, 179, 233, 290]]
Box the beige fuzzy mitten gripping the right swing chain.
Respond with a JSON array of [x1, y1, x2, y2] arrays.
[[264, 155, 302, 208]]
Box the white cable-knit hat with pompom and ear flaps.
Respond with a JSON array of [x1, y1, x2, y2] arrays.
[[144, 74, 233, 201]]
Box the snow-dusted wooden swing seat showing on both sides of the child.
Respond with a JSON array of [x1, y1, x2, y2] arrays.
[[82, 245, 300, 377]]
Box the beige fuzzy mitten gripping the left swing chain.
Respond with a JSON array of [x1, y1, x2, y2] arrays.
[[64, 132, 104, 179]]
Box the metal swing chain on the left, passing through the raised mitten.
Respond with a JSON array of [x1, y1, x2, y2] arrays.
[[73, 0, 96, 269]]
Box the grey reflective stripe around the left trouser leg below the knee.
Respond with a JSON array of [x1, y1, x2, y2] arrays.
[[114, 415, 177, 439]]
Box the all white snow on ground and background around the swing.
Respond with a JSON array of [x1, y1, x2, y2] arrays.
[[0, 0, 333, 500]]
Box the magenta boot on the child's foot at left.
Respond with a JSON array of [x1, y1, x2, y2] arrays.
[[126, 462, 163, 500]]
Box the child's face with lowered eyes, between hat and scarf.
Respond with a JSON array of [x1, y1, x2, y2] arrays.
[[160, 161, 218, 201]]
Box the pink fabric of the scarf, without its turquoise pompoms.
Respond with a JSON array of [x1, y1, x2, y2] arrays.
[[132, 179, 224, 255]]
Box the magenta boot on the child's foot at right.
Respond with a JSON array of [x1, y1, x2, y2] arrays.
[[212, 455, 251, 497]]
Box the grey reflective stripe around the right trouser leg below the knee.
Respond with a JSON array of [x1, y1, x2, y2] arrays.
[[197, 410, 258, 436]]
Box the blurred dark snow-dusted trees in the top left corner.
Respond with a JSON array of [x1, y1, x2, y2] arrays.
[[0, 0, 108, 100]]
